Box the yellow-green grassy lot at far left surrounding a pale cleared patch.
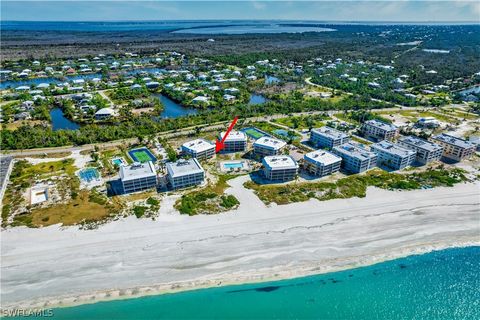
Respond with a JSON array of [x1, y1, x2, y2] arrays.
[[2, 159, 123, 227]]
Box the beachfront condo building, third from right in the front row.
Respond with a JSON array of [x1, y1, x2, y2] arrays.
[[371, 141, 417, 170]]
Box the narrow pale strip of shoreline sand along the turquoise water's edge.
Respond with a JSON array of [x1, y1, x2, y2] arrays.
[[12, 240, 480, 310]]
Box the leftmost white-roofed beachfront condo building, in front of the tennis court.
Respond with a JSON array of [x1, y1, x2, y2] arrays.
[[120, 161, 157, 193]]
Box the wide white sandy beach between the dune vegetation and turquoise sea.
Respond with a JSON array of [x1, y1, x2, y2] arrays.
[[1, 176, 480, 308]]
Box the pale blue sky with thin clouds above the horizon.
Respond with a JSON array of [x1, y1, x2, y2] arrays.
[[0, 0, 480, 23]]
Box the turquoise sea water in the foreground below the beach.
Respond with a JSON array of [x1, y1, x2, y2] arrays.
[[21, 246, 480, 320]]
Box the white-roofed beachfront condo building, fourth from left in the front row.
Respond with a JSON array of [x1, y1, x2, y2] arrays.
[[303, 150, 342, 177]]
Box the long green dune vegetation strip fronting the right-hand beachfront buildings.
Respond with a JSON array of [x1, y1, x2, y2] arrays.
[[244, 168, 467, 204]]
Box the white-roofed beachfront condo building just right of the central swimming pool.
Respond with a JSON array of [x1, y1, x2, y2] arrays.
[[262, 156, 298, 181]]
